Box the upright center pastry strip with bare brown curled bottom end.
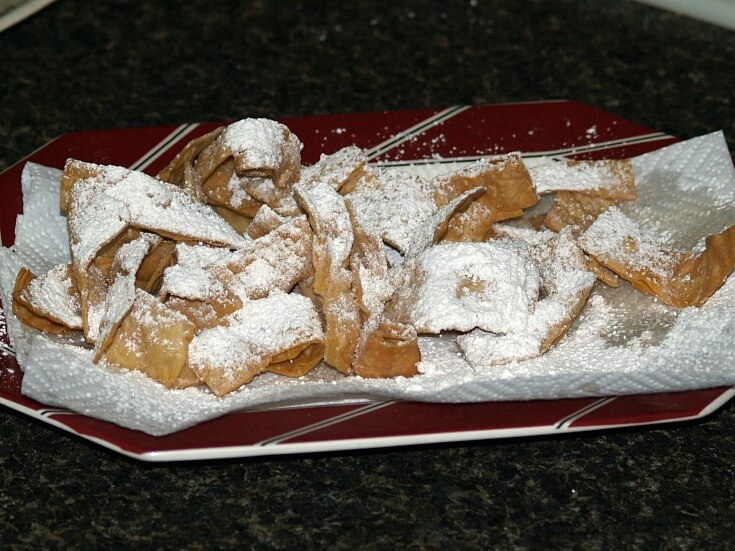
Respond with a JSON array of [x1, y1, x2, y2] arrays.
[[347, 201, 421, 378]]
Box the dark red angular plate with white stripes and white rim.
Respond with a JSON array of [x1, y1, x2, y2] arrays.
[[0, 101, 735, 461]]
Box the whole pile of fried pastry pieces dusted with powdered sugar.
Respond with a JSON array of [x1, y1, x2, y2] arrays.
[[13, 119, 735, 396]]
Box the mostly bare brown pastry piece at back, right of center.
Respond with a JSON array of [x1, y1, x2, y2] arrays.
[[432, 153, 538, 241]]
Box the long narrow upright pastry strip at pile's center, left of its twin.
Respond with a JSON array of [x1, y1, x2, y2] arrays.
[[294, 183, 361, 373]]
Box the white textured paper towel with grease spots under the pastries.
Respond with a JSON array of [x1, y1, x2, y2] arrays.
[[0, 132, 735, 435]]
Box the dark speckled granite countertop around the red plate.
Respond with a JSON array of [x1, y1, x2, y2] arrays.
[[0, 0, 735, 549]]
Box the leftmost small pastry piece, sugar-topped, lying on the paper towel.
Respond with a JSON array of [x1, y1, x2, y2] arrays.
[[12, 265, 82, 335]]
